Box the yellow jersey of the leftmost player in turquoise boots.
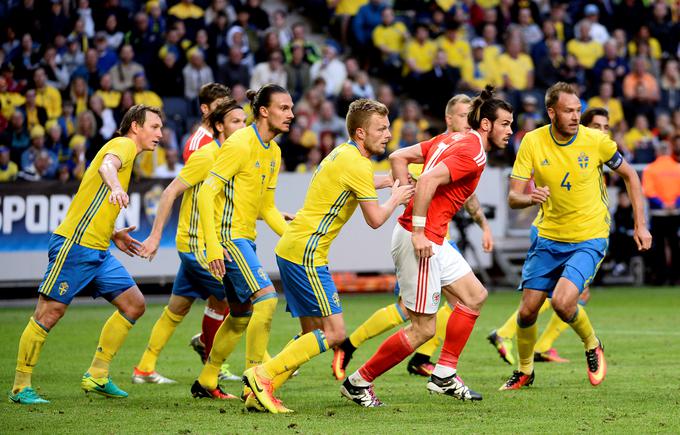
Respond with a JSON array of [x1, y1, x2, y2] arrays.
[[54, 137, 137, 251]]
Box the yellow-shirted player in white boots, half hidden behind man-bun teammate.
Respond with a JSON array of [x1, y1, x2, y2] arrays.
[[132, 98, 246, 394]]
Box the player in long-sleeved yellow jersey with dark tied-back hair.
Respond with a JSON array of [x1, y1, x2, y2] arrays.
[[191, 84, 294, 397]]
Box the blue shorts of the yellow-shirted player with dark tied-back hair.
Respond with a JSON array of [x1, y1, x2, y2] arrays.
[[224, 239, 272, 303]]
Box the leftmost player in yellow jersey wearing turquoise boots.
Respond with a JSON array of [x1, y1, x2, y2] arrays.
[[9, 105, 163, 404]]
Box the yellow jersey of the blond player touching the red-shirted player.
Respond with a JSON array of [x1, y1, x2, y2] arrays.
[[275, 141, 378, 267]]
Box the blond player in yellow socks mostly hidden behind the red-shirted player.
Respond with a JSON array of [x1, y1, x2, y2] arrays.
[[332, 94, 493, 380]]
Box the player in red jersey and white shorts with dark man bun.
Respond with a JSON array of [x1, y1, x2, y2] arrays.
[[340, 86, 512, 407]]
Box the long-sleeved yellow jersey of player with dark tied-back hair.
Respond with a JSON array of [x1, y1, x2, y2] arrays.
[[199, 124, 281, 261]]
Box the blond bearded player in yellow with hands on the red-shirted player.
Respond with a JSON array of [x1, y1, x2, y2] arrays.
[[243, 99, 413, 413]]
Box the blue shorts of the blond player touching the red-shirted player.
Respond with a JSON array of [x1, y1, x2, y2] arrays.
[[276, 255, 342, 317]]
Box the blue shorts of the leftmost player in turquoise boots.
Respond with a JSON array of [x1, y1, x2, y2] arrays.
[[38, 234, 135, 305]]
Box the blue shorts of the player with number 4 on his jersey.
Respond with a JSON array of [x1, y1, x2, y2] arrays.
[[519, 236, 609, 296]]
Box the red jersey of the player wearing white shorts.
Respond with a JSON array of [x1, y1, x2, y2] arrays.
[[399, 131, 486, 245]]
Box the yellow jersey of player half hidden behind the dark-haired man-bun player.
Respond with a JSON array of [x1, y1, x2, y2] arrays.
[[175, 140, 220, 254]]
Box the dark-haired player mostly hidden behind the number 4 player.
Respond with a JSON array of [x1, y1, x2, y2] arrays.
[[487, 107, 609, 365]]
